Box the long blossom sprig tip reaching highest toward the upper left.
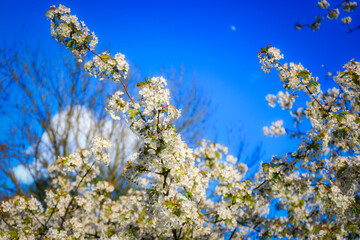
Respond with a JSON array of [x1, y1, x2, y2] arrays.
[[46, 4, 135, 107]]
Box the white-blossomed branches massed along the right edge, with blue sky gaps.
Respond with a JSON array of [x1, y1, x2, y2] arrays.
[[259, 46, 360, 239]]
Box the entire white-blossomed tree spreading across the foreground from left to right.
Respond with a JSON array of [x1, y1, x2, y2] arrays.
[[0, 5, 360, 239]]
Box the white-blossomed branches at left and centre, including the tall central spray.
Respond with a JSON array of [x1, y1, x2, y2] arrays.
[[1, 5, 261, 239]]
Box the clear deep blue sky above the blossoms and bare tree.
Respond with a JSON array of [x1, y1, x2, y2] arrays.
[[0, 0, 360, 169]]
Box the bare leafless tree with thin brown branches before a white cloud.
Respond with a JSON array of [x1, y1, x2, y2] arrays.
[[0, 35, 209, 200]]
